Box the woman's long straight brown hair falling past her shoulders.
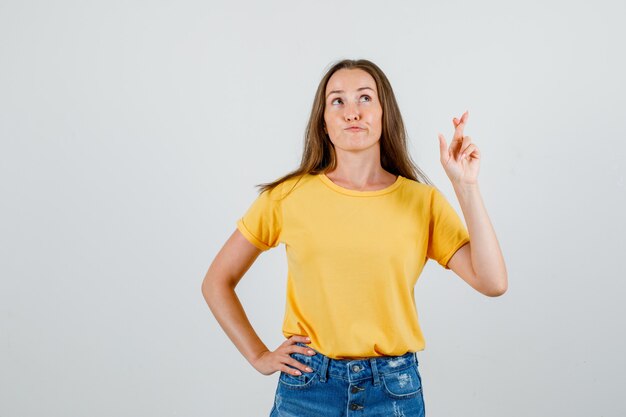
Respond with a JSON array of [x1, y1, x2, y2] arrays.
[[256, 59, 432, 193]]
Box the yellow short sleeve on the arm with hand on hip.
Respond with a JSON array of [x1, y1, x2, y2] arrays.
[[237, 185, 282, 251]]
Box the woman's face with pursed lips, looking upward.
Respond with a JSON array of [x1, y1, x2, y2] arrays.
[[324, 68, 383, 151]]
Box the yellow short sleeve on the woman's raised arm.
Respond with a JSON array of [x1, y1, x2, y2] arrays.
[[427, 187, 470, 269]]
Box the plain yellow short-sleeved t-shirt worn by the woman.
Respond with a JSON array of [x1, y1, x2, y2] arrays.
[[237, 174, 469, 359]]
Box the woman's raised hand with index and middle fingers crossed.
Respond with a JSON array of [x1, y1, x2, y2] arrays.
[[439, 111, 480, 185]]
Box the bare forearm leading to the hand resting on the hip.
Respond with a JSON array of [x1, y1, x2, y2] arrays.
[[202, 284, 269, 364]]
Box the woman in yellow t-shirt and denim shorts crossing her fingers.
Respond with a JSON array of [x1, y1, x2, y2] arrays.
[[202, 60, 508, 417]]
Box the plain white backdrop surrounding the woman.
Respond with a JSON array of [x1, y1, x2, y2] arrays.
[[0, 0, 626, 417]]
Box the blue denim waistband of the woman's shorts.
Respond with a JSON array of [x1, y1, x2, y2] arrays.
[[291, 342, 418, 385]]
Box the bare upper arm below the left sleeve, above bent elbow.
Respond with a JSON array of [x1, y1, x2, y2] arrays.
[[202, 229, 263, 289]]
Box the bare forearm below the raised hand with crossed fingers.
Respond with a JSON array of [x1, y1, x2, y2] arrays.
[[453, 183, 508, 292]]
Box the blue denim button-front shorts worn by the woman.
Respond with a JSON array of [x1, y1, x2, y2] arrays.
[[270, 342, 425, 417]]
